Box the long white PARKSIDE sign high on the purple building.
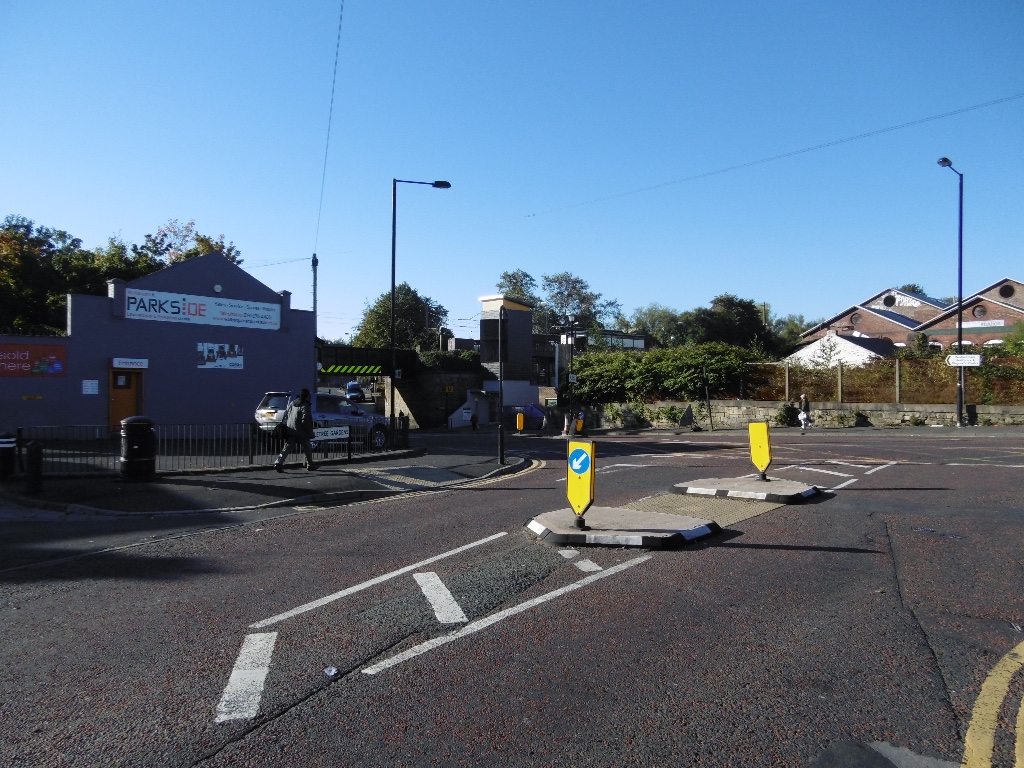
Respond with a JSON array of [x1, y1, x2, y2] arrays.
[[125, 288, 281, 331]]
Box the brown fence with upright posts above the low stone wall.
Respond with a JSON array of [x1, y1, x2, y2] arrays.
[[742, 357, 1024, 406]]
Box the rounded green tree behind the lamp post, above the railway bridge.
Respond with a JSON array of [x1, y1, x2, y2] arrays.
[[352, 283, 449, 349]]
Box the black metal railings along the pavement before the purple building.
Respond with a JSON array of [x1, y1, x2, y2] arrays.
[[4, 423, 387, 475]]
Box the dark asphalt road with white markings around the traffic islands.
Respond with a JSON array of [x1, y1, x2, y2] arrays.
[[0, 429, 1024, 767]]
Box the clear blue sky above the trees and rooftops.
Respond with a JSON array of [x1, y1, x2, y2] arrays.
[[0, 0, 1024, 338]]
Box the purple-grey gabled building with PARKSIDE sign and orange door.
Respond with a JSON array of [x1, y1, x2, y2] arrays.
[[0, 254, 316, 431]]
